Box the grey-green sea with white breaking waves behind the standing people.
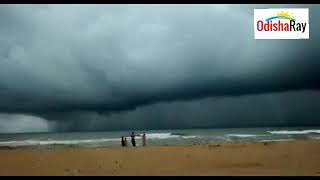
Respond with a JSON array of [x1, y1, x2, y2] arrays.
[[0, 127, 320, 148]]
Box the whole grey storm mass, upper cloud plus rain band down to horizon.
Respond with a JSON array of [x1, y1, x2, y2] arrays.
[[0, 5, 320, 131]]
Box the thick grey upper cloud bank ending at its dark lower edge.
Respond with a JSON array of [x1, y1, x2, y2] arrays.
[[0, 5, 320, 112]]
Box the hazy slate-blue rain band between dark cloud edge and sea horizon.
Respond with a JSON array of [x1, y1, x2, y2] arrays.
[[42, 91, 320, 131]]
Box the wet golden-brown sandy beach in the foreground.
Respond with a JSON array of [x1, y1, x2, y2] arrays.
[[0, 140, 320, 176]]
